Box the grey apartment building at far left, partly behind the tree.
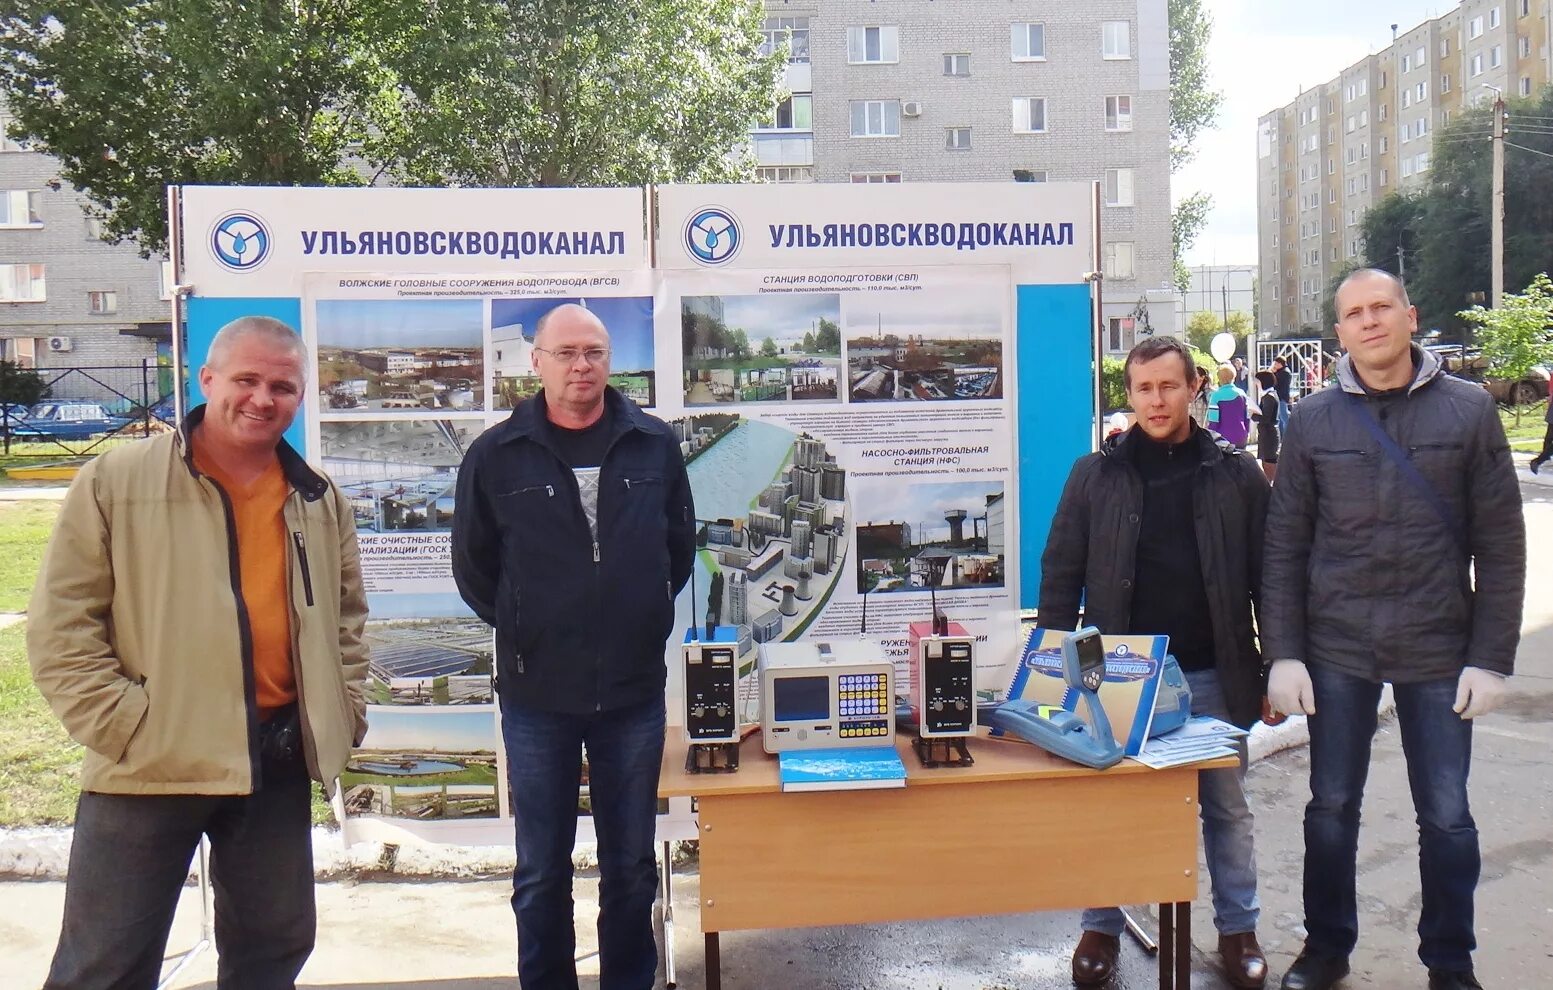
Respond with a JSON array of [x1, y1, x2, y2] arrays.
[[0, 113, 172, 377]]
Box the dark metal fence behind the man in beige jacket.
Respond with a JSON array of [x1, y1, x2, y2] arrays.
[[0, 357, 174, 460]]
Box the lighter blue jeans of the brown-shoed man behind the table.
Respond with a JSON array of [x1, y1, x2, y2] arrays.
[[1081, 670, 1261, 936]]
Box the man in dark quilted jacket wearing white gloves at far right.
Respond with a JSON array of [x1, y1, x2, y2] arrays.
[[1261, 269, 1527, 990]]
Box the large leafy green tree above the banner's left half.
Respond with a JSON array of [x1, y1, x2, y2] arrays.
[[0, 0, 781, 255]]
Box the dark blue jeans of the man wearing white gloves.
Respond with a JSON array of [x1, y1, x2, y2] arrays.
[[1305, 664, 1480, 970]]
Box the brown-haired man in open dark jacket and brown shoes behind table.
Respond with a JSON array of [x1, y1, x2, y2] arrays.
[[1039, 337, 1267, 987]]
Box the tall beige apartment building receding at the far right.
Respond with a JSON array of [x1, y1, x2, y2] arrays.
[[1256, 0, 1553, 337]]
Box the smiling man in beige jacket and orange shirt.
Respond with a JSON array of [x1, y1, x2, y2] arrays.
[[26, 317, 367, 990]]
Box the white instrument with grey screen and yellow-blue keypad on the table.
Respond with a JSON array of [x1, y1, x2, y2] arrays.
[[761, 640, 895, 752]]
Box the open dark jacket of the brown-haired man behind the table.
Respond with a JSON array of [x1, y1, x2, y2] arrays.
[[1039, 427, 1267, 727]]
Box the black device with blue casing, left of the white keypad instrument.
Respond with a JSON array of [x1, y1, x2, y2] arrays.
[[680, 626, 739, 774]]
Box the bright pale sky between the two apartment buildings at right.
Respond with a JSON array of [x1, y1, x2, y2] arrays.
[[1171, 0, 1455, 264]]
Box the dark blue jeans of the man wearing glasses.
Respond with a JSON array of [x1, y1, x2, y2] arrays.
[[502, 698, 665, 990]]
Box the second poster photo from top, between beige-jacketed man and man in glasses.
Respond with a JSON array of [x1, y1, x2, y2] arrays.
[[318, 420, 485, 533]]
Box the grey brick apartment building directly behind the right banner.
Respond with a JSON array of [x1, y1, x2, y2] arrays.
[[752, 0, 1177, 353]]
